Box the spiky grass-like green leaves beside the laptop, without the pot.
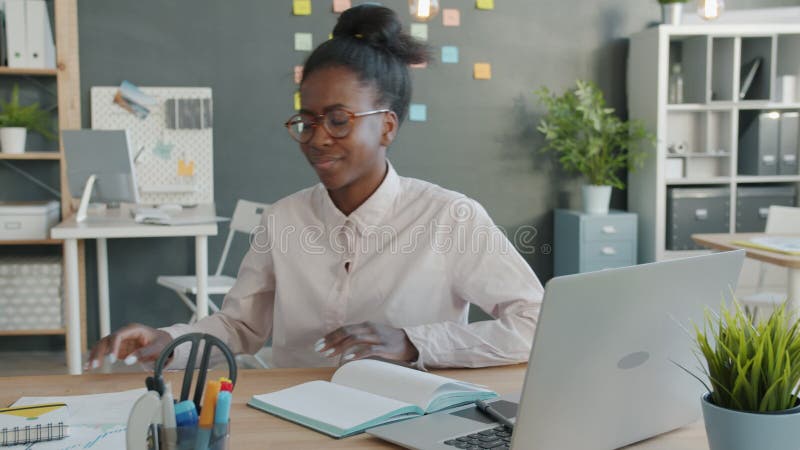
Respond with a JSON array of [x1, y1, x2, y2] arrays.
[[684, 302, 800, 412]]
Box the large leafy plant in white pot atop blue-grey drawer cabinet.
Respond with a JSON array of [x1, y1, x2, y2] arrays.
[[536, 80, 654, 214]]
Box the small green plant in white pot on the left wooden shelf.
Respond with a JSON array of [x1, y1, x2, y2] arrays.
[[0, 85, 55, 153]]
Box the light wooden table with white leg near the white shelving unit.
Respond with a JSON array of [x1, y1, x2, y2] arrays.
[[692, 233, 800, 310]]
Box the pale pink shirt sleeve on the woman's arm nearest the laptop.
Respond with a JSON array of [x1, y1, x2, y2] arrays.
[[403, 201, 544, 368]]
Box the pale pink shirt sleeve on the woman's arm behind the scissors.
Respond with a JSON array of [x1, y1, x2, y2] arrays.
[[162, 210, 275, 368]]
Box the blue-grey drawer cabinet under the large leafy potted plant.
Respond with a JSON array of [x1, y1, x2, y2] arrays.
[[553, 209, 637, 276]]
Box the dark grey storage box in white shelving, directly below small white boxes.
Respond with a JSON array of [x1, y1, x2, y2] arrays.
[[666, 187, 730, 250]]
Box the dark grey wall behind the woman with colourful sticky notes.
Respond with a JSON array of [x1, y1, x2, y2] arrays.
[[0, 0, 797, 348]]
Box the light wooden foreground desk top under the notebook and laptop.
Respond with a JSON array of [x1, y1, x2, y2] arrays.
[[0, 365, 708, 450]]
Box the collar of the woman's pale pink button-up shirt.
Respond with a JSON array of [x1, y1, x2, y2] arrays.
[[317, 160, 400, 235]]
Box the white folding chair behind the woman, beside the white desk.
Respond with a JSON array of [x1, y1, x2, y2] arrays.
[[156, 200, 269, 368]]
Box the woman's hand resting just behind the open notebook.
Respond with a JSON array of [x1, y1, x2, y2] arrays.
[[314, 322, 419, 363]]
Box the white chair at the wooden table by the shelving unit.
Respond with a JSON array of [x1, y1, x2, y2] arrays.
[[739, 205, 800, 318]]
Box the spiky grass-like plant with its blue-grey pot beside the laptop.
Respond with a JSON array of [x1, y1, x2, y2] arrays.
[[684, 302, 800, 450]]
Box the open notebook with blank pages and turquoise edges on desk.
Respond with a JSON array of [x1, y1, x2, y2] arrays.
[[247, 359, 497, 438]]
